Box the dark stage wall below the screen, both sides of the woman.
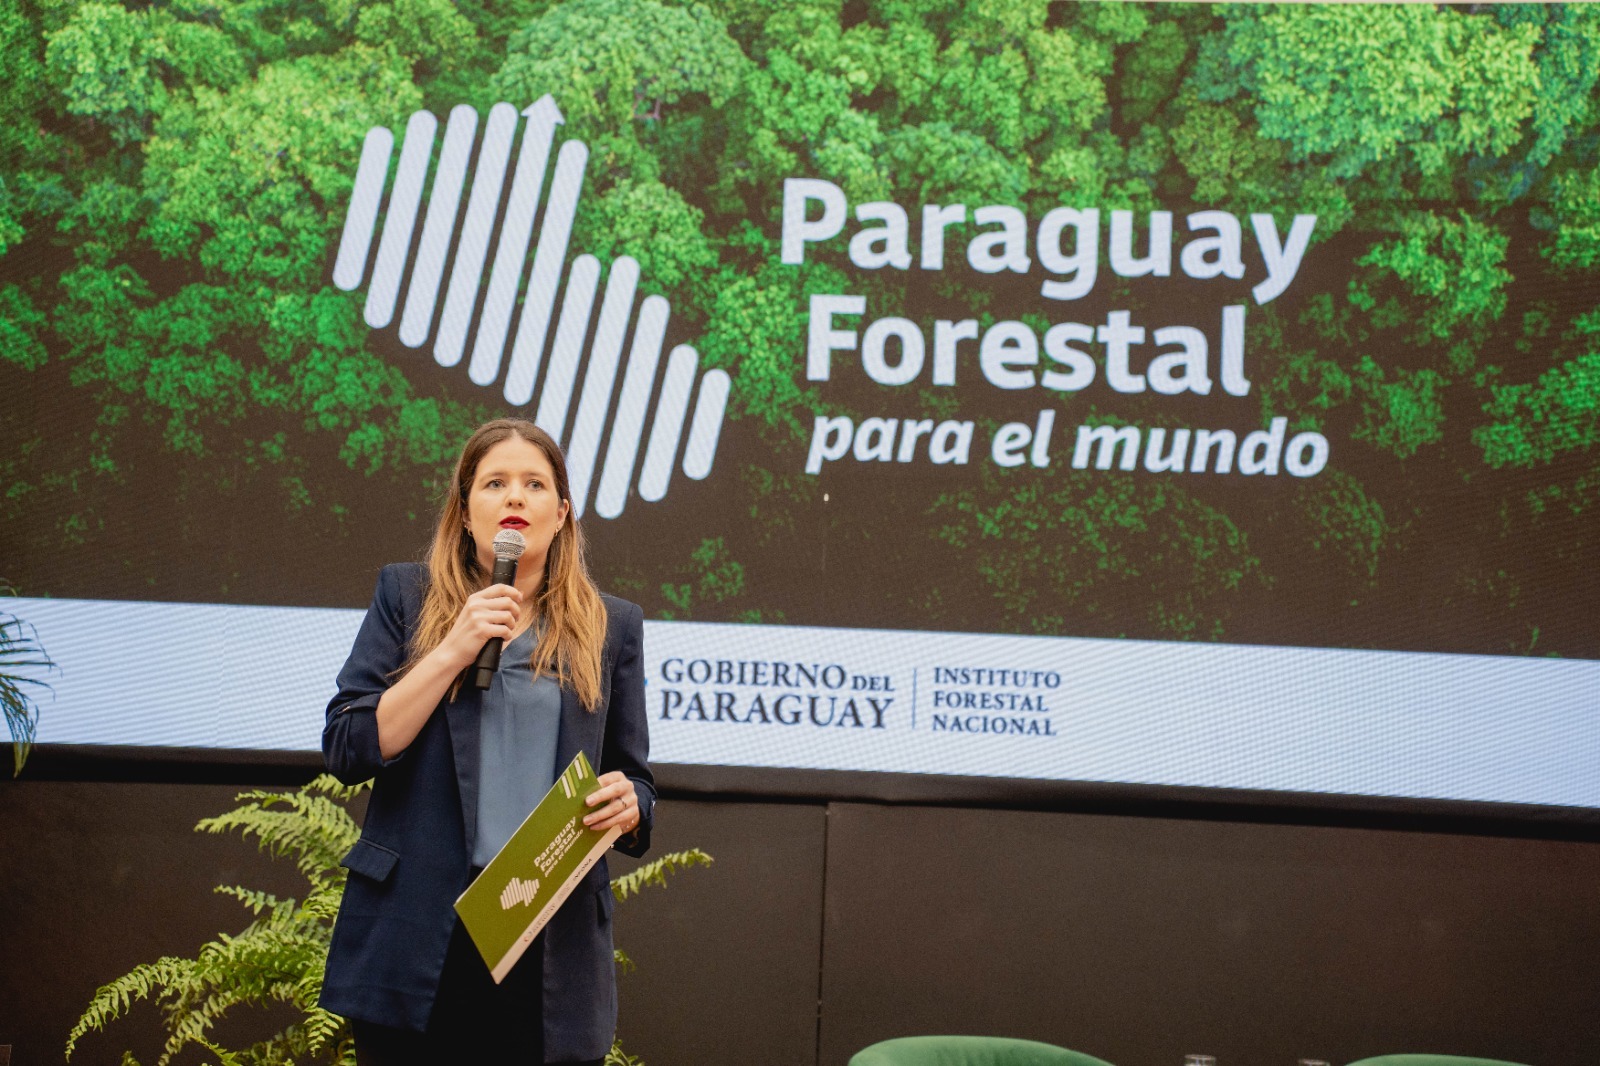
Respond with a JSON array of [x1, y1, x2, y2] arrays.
[[0, 779, 1600, 1066]]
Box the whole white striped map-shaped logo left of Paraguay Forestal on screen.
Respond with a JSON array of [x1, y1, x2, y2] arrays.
[[333, 94, 731, 519]]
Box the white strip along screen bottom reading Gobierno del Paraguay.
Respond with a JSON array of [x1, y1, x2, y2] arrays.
[[12, 599, 1600, 807]]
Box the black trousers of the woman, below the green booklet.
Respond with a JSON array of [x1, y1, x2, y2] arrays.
[[352, 920, 600, 1066]]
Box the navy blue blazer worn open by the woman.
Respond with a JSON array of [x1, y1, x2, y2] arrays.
[[322, 563, 656, 1061]]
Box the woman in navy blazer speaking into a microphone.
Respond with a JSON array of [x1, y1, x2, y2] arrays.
[[322, 419, 656, 1066]]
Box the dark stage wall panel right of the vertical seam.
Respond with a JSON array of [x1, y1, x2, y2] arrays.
[[818, 804, 1600, 1066]]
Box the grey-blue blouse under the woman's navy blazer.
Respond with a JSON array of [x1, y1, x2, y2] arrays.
[[472, 626, 562, 866]]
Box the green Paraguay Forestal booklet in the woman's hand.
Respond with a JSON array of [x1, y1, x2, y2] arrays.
[[456, 752, 622, 984]]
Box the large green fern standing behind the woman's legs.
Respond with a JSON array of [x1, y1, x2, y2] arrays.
[[67, 775, 712, 1066]]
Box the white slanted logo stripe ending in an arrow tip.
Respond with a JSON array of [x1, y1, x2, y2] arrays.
[[467, 94, 562, 384]]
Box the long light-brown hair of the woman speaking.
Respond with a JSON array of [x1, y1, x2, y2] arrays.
[[403, 418, 606, 711]]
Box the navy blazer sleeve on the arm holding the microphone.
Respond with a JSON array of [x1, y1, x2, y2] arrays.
[[322, 565, 406, 784]]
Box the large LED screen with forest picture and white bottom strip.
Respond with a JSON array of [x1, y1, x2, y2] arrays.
[[0, 0, 1600, 808]]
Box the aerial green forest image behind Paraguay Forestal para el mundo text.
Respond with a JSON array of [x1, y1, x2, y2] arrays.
[[0, 0, 1600, 658]]
